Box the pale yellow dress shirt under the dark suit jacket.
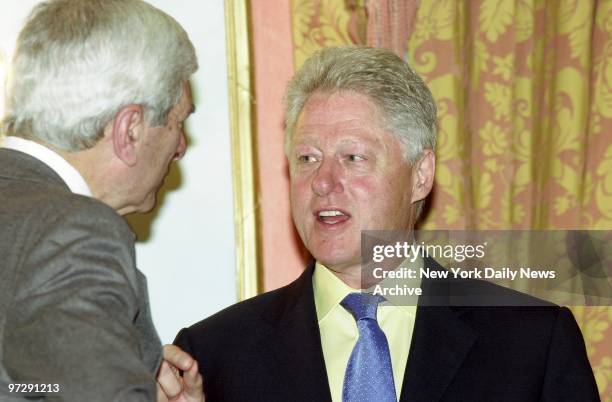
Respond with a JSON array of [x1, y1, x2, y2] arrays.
[[312, 262, 416, 402]]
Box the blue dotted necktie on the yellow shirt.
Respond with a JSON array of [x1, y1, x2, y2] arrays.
[[340, 293, 397, 402]]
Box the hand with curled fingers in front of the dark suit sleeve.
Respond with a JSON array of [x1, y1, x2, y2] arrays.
[[157, 345, 204, 402]]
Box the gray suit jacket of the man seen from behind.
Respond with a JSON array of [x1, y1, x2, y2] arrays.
[[0, 149, 161, 402]]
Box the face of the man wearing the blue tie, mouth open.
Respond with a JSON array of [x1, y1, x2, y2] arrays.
[[288, 92, 415, 270]]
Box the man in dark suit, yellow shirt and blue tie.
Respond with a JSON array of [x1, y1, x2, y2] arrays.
[[175, 47, 598, 402]]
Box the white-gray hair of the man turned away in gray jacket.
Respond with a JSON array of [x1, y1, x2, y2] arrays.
[[3, 0, 198, 151]]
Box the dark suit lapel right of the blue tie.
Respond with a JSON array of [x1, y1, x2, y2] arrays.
[[400, 260, 478, 402]]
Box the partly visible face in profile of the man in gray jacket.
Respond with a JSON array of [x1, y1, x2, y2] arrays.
[[134, 83, 193, 212]]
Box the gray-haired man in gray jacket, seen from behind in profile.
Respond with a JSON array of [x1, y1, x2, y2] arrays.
[[0, 0, 203, 402]]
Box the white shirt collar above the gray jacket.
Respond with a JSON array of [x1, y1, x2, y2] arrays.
[[2, 136, 92, 197]]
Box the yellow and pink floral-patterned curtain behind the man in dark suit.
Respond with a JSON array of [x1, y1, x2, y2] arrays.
[[291, 0, 612, 401]]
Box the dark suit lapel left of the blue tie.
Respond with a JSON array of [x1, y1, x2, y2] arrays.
[[262, 263, 331, 402]]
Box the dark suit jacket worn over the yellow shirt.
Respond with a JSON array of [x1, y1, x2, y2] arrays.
[[175, 260, 599, 402]]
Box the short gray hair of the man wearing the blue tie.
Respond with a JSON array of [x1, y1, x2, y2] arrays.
[[285, 46, 436, 162]]
